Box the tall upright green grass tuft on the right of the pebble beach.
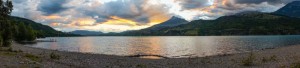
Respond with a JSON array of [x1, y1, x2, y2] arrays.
[[242, 52, 255, 66]]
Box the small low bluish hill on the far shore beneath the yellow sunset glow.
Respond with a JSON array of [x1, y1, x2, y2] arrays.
[[70, 30, 103, 36]]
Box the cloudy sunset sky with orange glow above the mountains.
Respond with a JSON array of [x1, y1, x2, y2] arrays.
[[12, 0, 294, 32]]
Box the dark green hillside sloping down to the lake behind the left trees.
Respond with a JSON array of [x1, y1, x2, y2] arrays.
[[11, 16, 79, 37]]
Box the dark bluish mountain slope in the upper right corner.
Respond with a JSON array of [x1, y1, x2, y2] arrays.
[[274, 1, 300, 18]]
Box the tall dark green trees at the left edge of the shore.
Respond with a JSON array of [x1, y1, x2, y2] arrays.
[[0, 0, 36, 47]]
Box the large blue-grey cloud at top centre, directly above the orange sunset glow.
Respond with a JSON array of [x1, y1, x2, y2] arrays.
[[101, 1, 149, 23]]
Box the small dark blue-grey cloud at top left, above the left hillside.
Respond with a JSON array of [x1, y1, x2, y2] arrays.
[[38, 0, 68, 15]]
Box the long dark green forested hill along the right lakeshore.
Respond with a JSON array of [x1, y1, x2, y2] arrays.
[[157, 12, 300, 36]]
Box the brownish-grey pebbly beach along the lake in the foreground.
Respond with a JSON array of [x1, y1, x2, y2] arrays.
[[0, 43, 300, 68]]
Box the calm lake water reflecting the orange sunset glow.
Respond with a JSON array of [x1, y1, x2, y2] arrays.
[[23, 35, 300, 58]]
